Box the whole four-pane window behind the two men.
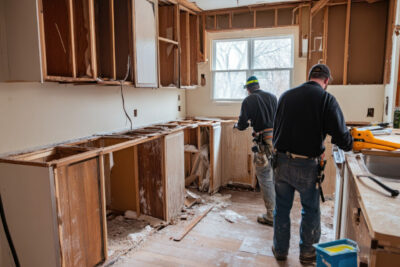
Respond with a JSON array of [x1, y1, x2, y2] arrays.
[[212, 36, 293, 101]]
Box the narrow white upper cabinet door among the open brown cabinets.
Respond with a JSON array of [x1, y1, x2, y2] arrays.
[[134, 0, 158, 88]]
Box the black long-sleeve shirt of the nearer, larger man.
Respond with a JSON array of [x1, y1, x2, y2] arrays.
[[273, 81, 353, 157]]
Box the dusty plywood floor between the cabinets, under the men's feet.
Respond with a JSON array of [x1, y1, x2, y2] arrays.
[[109, 190, 333, 267]]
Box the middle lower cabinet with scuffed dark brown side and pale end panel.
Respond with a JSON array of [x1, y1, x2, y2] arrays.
[[113, 127, 185, 221]]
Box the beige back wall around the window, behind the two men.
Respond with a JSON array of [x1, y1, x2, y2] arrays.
[[186, 27, 385, 122]]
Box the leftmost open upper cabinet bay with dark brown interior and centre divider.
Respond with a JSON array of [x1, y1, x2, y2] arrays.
[[38, 0, 97, 82]]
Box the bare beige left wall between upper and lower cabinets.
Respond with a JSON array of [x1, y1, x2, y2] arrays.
[[0, 83, 185, 153]]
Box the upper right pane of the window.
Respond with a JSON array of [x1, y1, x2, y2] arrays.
[[253, 38, 293, 69]]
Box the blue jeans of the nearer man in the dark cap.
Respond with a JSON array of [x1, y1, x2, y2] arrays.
[[274, 153, 321, 256]]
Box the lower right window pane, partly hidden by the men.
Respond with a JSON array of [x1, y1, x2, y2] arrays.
[[254, 70, 290, 98]]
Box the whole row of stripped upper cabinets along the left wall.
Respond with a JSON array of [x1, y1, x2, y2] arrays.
[[0, 0, 200, 85]]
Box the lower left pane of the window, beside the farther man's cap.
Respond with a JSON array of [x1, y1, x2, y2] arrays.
[[214, 71, 247, 99]]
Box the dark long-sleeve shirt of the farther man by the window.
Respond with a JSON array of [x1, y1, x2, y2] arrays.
[[238, 90, 278, 132]]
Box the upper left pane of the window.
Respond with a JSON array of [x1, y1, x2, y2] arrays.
[[214, 41, 247, 70]]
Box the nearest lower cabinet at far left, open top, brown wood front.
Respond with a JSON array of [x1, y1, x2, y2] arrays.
[[0, 147, 107, 267]]
